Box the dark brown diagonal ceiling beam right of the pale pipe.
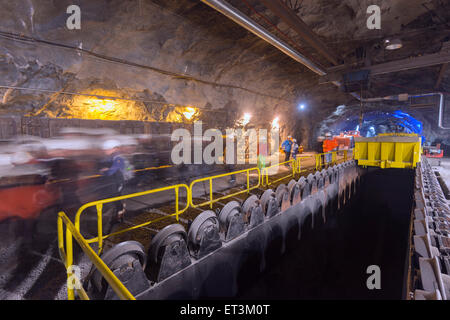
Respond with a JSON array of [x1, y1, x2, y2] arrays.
[[261, 0, 339, 65]]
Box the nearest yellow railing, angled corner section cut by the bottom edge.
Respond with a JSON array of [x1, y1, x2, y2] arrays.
[[58, 211, 135, 300]]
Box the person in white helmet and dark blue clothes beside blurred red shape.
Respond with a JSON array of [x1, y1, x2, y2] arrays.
[[100, 140, 126, 221]]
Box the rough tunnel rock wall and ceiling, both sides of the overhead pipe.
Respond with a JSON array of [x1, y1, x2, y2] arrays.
[[0, 0, 448, 146]]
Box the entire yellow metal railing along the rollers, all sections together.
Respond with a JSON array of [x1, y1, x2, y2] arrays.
[[58, 151, 347, 300]]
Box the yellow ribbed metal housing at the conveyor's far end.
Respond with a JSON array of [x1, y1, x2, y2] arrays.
[[354, 133, 421, 169]]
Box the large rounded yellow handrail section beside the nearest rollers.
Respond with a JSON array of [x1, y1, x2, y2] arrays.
[[75, 184, 190, 253]]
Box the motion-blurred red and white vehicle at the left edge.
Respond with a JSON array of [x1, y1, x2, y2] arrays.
[[0, 128, 144, 221]]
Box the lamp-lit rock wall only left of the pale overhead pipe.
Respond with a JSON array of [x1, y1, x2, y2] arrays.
[[0, 0, 324, 142]]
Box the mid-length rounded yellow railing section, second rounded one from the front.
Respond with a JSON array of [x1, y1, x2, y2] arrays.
[[189, 167, 261, 208]]
